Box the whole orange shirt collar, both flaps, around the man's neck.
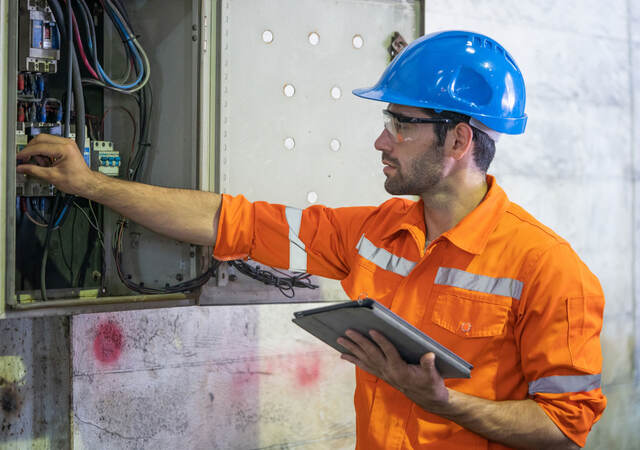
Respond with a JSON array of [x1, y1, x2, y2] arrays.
[[383, 175, 510, 255]]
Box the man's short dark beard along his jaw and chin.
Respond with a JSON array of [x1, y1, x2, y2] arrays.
[[383, 143, 444, 195]]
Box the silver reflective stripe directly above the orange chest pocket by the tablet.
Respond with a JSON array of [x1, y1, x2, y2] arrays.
[[435, 267, 523, 300]]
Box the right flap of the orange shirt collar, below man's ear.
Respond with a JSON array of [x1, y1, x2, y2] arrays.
[[440, 175, 510, 255]]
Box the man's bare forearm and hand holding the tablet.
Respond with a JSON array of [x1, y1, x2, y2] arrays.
[[338, 330, 579, 450]]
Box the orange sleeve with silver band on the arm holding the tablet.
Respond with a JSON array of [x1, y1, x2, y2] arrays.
[[515, 242, 607, 446]]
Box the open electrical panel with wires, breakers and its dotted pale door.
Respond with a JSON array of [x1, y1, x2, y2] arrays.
[[0, 0, 423, 316]]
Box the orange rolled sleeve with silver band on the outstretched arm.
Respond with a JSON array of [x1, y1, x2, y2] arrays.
[[213, 194, 374, 279]]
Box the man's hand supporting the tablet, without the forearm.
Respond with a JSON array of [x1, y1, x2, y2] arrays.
[[338, 330, 449, 410]]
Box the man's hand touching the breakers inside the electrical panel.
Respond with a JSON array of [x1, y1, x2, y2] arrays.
[[16, 134, 94, 196]]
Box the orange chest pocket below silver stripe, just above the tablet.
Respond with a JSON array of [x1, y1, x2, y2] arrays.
[[431, 294, 511, 338]]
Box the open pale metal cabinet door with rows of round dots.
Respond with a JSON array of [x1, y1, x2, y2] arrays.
[[200, 0, 424, 304]]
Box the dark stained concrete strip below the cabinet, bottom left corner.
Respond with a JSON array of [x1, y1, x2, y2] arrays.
[[0, 317, 71, 450]]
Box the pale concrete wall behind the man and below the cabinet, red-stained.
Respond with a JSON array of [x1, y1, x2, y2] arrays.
[[0, 0, 640, 449]]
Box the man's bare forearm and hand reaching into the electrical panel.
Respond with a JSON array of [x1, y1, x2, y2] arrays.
[[17, 134, 222, 245]]
